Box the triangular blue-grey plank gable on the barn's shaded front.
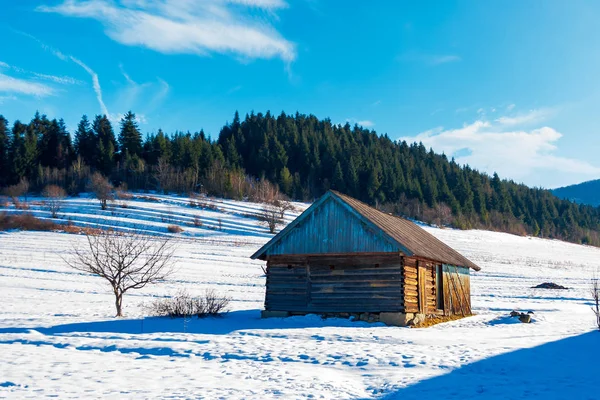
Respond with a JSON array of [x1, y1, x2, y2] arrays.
[[252, 192, 411, 259]]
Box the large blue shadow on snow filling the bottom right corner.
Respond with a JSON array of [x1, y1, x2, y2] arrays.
[[383, 331, 600, 400]]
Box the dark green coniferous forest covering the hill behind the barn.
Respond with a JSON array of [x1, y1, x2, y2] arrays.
[[0, 112, 600, 246]]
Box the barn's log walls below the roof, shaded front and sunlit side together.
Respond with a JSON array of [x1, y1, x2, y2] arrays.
[[265, 253, 471, 315]]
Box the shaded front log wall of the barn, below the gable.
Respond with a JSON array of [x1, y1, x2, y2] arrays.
[[265, 254, 404, 313]]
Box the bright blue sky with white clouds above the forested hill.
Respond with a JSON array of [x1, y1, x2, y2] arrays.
[[0, 0, 600, 187]]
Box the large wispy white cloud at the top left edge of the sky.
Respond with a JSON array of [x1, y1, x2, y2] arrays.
[[38, 0, 296, 63]]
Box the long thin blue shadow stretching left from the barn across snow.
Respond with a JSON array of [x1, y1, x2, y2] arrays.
[[0, 309, 383, 335]]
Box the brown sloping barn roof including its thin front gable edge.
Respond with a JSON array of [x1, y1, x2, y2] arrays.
[[252, 190, 480, 271]]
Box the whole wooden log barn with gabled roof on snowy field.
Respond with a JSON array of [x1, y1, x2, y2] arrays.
[[251, 191, 479, 325]]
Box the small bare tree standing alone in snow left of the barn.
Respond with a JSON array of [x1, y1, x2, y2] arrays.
[[65, 230, 175, 317]]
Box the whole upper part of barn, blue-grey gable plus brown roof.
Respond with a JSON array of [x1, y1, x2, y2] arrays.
[[251, 190, 480, 271]]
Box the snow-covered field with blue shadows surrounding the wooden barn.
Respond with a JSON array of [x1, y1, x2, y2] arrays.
[[0, 195, 600, 399]]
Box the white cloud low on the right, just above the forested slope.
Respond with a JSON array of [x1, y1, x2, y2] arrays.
[[401, 112, 600, 185]]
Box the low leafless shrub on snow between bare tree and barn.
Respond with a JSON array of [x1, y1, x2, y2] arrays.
[[148, 290, 230, 318]]
